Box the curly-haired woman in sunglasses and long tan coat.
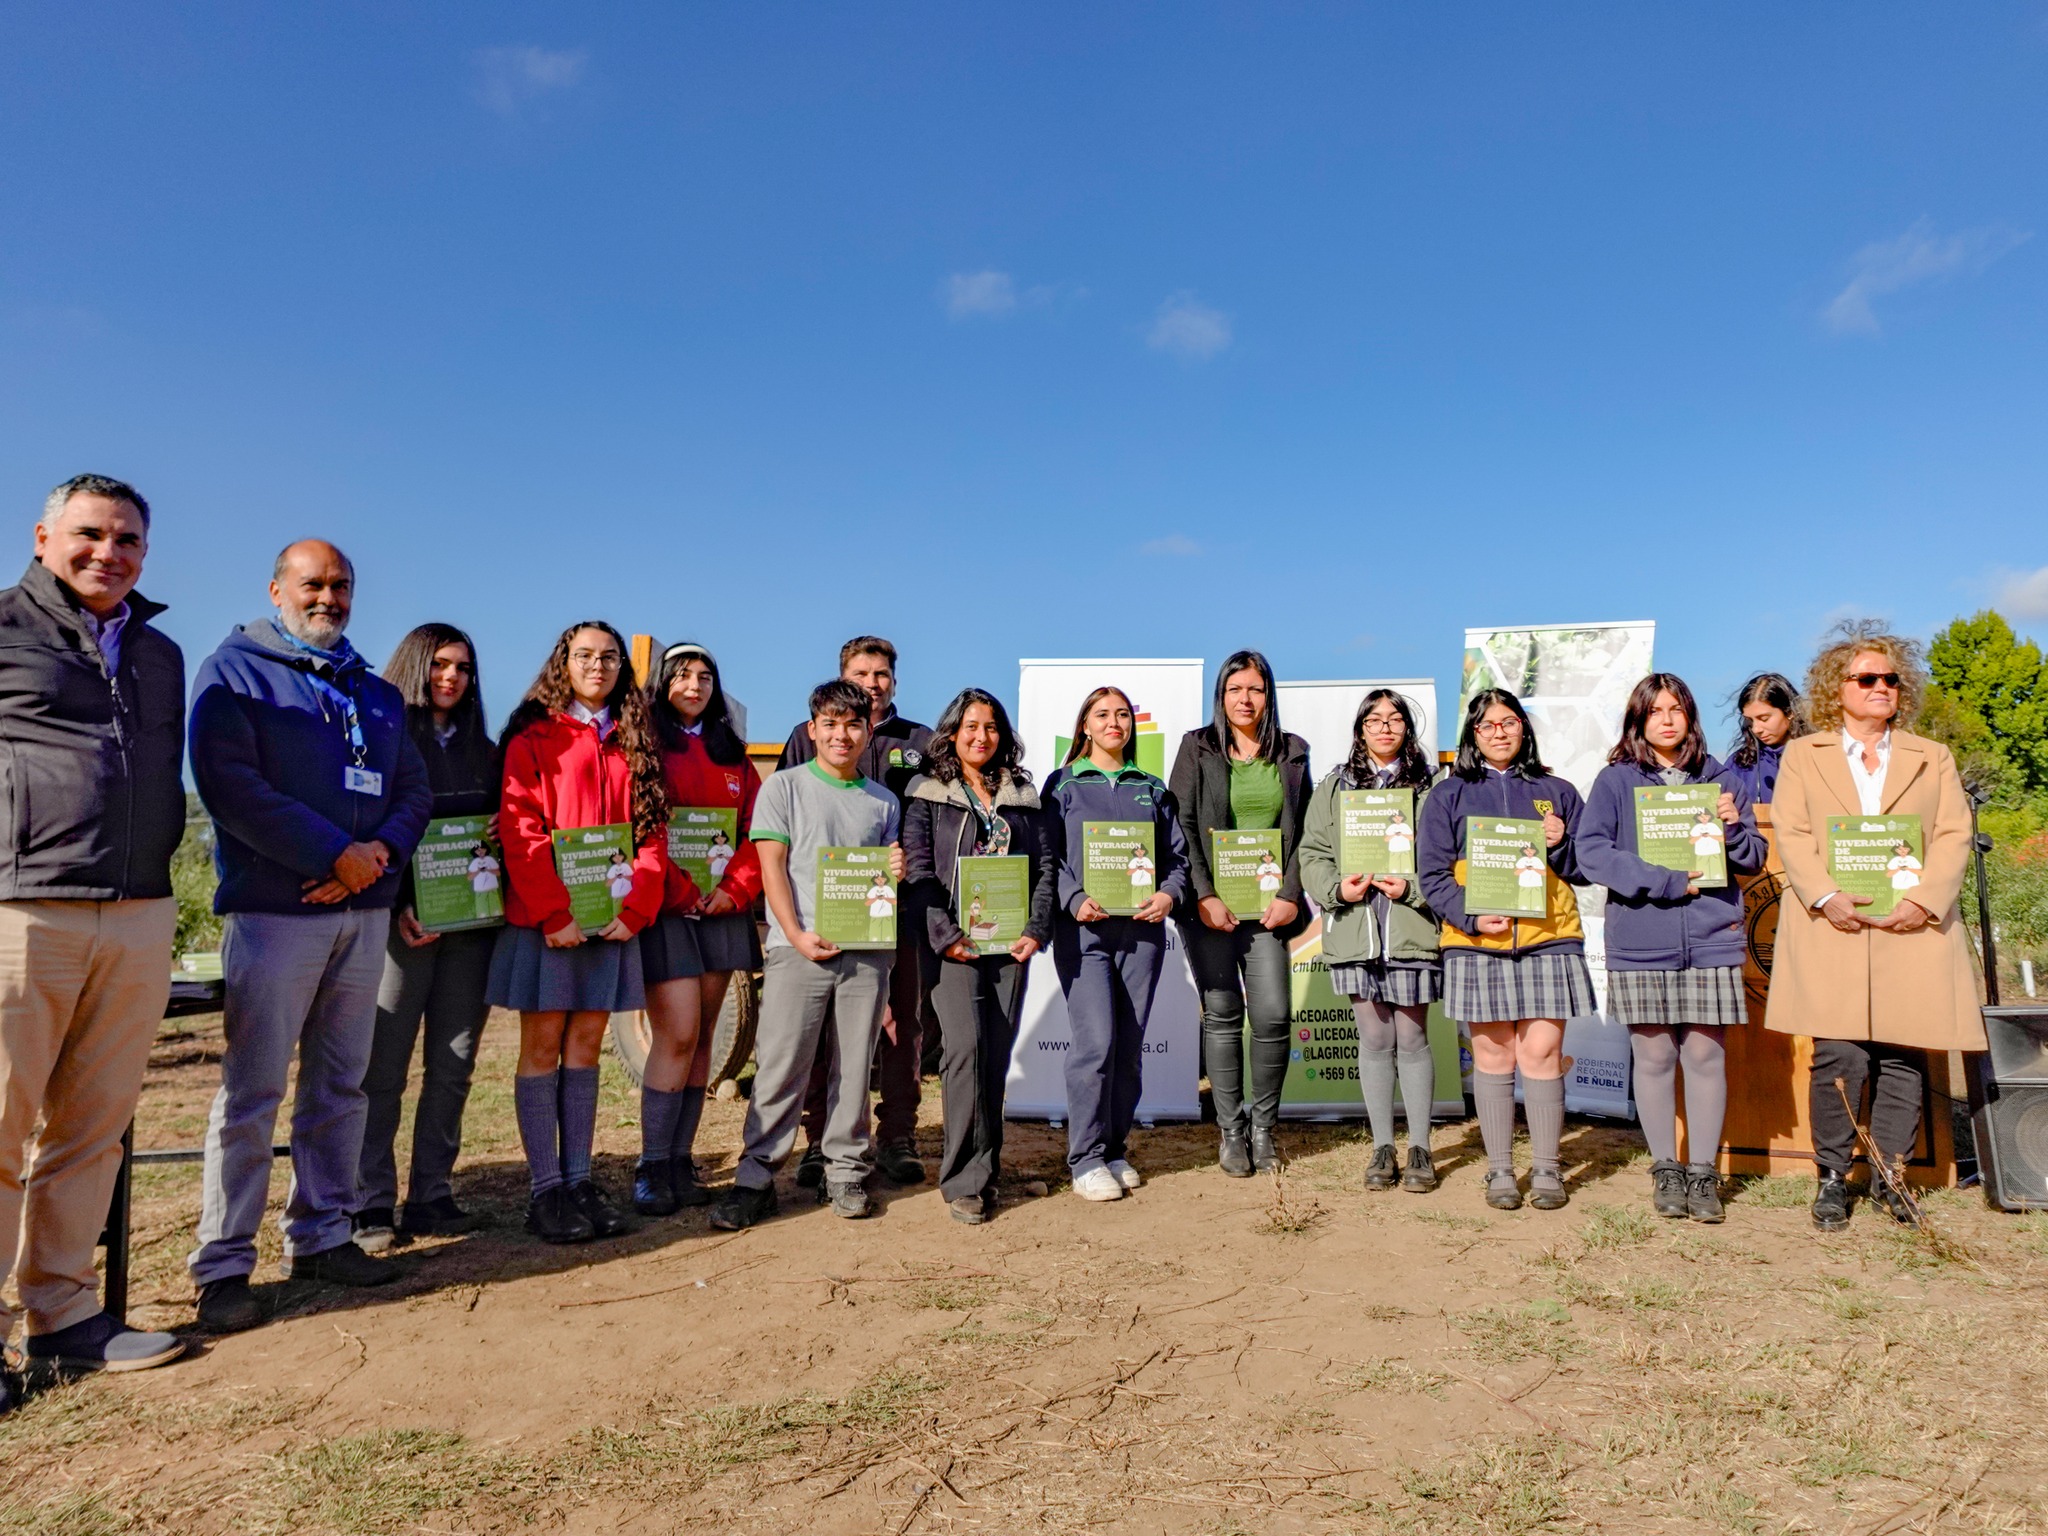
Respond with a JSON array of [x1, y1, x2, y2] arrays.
[[1763, 623, 1985, 1231]]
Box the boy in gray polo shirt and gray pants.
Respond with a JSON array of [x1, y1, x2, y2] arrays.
[[711, 678, 903, 1231]]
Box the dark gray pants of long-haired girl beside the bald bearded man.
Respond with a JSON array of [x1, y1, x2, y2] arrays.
[[356, 924, 498, 1210]]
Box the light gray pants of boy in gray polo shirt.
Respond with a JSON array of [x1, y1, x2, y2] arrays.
[[733, 946, 895, 1190]]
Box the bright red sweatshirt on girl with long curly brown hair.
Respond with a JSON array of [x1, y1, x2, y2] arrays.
[[498, 713, 668, 934]]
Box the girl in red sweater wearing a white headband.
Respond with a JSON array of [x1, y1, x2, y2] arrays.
[[633, 641, 762, 1217]]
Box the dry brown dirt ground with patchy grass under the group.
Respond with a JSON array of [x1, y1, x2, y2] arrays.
[[0, 1016, 2048, 1536]]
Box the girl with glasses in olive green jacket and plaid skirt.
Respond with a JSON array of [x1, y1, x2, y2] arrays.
[[1300, 688, 1444, 1194]]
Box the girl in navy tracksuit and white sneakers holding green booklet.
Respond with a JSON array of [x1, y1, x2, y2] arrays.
[[1040, 688, 1188, 1200]]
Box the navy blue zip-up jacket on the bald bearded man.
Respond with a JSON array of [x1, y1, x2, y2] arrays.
[[190, 618, 434, 913]]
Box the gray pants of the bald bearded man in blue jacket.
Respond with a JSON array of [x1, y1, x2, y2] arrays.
[[186, 909, 391, 1284]]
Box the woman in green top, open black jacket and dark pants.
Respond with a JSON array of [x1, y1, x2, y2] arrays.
[[1171, 651, 1313, 1178]]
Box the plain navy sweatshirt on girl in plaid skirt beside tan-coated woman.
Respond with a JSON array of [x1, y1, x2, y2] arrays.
[[1577, 758, 1767, 971]]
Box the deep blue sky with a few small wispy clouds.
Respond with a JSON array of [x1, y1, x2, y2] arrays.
[[0, 0, 2048, 753]]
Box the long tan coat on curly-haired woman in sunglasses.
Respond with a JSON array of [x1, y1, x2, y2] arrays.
[[1763, 729, 1985, 1051]]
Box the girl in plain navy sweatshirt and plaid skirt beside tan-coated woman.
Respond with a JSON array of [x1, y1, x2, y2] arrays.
[[1577, 672, 1767, 1221]]
